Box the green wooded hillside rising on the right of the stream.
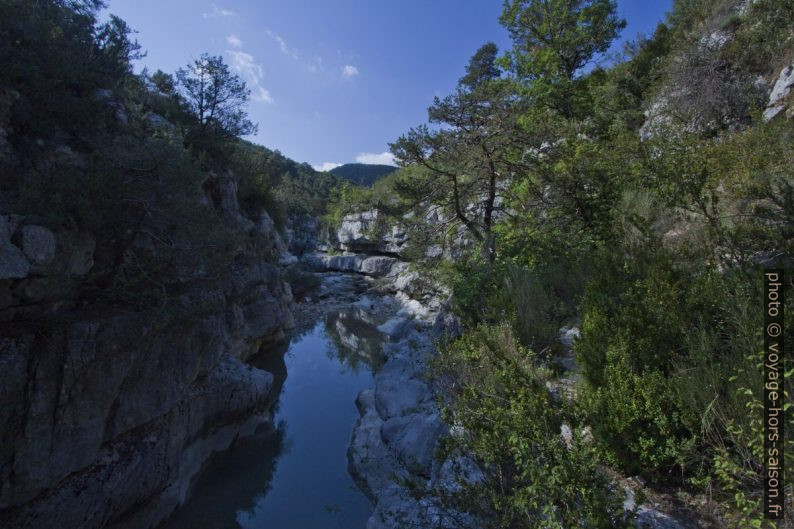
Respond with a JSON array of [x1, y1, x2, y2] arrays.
[[329, 0, 794, 528]]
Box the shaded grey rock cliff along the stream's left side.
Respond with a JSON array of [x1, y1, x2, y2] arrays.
[[0, 170, 292, 529]]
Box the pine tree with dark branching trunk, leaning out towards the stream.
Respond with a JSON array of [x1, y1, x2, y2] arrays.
[[391, 43, 519, 261]]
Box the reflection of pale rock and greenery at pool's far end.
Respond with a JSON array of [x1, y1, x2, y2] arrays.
[[325, 308, 388, 370]]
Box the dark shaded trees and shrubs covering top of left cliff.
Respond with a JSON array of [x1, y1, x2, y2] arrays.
[[0, 0, 339, 310]]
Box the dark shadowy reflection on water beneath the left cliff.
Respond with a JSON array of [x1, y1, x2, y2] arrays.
[[160, 423, 286, 529]]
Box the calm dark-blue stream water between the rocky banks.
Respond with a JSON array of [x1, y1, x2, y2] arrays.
[[161, 311, 382, 529]]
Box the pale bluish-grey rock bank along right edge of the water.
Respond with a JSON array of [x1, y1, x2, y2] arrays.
[[348, 292, 454, 529]]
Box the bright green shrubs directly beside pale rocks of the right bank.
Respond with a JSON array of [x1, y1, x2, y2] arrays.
[[434, 324, 630, 529]]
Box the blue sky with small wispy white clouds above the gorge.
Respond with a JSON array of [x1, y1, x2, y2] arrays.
[[108, 0, 672, 167]]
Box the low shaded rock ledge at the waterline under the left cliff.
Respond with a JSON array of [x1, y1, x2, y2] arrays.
[[0, 355, 273, 529]]
